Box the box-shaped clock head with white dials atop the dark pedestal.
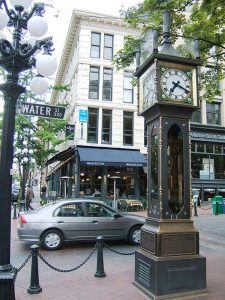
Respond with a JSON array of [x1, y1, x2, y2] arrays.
[[139, 58, 197, 114]]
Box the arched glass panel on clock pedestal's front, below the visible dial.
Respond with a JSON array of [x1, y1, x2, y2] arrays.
[[167, 124, 184, 214]]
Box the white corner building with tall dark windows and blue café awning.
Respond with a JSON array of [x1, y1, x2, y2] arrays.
[[48, 11, 147, 202]]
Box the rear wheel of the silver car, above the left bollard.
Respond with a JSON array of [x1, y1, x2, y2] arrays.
[[41, 229, 63, 250]]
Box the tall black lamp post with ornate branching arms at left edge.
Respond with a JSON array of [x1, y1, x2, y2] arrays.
[[0, 0, 54, 300]]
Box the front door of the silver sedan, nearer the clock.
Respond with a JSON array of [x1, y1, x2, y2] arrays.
[[86, 202, 126, 239]]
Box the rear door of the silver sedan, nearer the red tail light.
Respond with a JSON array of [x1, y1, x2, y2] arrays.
[[54, 202, 89, 241]]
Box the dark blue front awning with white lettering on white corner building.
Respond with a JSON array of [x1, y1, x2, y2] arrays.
[[77, 146, 147, 167]]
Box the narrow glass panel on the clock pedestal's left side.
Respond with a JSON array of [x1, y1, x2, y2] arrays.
[[149, 126, 159, 214]]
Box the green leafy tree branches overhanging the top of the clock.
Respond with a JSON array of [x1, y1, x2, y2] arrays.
[[113, 0, 225, 102]]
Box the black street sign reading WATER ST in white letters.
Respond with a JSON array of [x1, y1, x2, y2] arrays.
[[18, 102, 66, 119]]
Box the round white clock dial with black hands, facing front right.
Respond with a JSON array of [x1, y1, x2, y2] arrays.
[[161, 69, 191, 101]]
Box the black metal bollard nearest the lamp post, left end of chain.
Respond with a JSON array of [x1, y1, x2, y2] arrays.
[[27, 245, 42, 294]]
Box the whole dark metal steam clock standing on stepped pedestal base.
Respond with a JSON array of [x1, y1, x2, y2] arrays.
[[134, 12, 206, 299]]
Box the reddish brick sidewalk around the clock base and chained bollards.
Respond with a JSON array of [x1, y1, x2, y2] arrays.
[[12, 198, 225, 300]]
